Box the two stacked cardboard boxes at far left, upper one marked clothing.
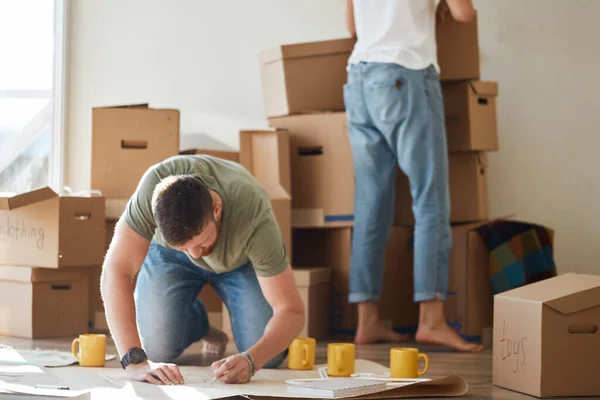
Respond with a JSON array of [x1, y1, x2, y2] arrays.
[[0, 187, 104, 338]]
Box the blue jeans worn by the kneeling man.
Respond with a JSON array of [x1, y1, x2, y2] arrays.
[[135, 242, 287, 368]]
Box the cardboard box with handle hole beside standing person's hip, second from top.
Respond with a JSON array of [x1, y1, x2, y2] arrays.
[[442, 81, 498, 152]]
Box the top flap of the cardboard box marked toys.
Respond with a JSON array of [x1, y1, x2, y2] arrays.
[[496, 273, 600, 312]]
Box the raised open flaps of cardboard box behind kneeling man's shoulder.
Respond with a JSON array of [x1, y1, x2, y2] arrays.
[[239, 129, 292, 195]]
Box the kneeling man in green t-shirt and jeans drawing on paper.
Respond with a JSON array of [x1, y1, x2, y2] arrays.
[[101, 155, 304, 384]]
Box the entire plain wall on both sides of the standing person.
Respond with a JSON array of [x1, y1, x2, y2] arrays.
[[67, 0, 600, 274]]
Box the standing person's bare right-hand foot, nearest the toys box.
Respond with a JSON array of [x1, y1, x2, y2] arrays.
[[416, 300, 483, 353]]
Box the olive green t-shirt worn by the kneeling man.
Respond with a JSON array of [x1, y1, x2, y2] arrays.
[[124, 155, 289, 277]]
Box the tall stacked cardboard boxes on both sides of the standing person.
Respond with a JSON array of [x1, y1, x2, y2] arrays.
[[251, 14, 498, 339]]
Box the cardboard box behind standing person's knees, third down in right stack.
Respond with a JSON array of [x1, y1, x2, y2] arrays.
[[395, 152, 489, 225]]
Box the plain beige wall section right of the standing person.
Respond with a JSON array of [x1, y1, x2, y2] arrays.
[[475, 0, 600, 274]]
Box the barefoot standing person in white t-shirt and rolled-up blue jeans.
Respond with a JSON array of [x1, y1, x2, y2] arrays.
[[344, 0, 482, 352]]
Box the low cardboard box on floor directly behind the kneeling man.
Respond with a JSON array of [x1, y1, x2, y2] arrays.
[[222, 267, 332, 340]]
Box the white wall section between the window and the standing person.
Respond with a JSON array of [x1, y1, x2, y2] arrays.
[[66, 0, 348, 189]]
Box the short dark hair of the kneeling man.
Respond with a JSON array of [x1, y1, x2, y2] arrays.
[[152, 175, 215, 246]]
